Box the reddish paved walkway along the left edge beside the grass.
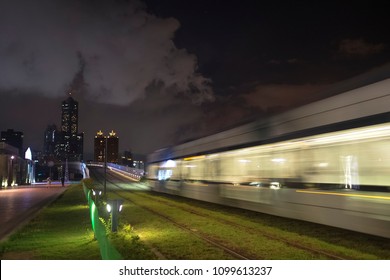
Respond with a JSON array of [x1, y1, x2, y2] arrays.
[[0, 182, 66, 241]]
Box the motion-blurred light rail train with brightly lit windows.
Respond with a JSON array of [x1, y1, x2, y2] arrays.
[[147, 79, 390, 238]]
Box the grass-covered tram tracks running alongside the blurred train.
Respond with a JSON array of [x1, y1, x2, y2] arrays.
[[91, 166, 350, 260]]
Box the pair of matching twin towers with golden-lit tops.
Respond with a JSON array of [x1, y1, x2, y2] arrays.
[[94, 130, 119, 163]]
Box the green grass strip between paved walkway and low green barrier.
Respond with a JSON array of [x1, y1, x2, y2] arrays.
[[0, 184, 101, 260]]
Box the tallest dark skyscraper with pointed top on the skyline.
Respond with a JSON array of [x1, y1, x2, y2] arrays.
[[57, 93, 84, 161]]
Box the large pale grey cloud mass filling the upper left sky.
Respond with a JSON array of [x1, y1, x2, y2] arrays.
[[0, 0, 213, 105]]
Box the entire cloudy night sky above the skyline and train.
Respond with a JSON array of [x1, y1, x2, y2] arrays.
[[0, 0, 390, 159]]
